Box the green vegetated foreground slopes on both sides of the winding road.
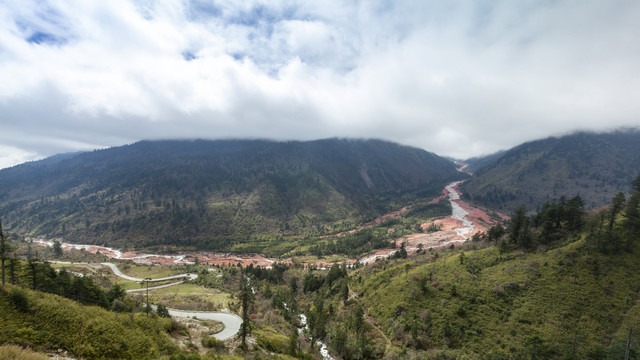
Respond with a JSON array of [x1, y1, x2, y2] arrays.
[[0, 177, 640, 360]]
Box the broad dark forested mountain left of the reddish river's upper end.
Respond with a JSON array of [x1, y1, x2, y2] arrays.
[[0, 139, 460, 250]]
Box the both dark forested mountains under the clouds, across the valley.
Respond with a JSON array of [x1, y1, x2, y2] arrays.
[[0, 130, 640, 252]]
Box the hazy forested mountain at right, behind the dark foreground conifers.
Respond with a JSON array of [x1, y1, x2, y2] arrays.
[[462, 130, 640, 211]]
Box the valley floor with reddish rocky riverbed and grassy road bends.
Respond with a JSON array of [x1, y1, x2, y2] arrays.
[[7, 176, 499, 359]]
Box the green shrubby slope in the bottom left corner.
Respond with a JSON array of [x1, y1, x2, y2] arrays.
[[0, 285, 175, 359]]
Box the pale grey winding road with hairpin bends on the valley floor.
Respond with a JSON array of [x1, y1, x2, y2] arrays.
[[101, 263, 242, 340]]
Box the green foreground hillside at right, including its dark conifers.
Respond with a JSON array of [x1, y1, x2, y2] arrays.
[[231, 178, 640, 359]]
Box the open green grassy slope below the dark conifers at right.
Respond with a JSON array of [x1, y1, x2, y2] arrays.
[[356, 240, 640, 358]]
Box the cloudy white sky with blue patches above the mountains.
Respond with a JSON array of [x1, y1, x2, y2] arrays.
[[0, 0, 640, 168]]
